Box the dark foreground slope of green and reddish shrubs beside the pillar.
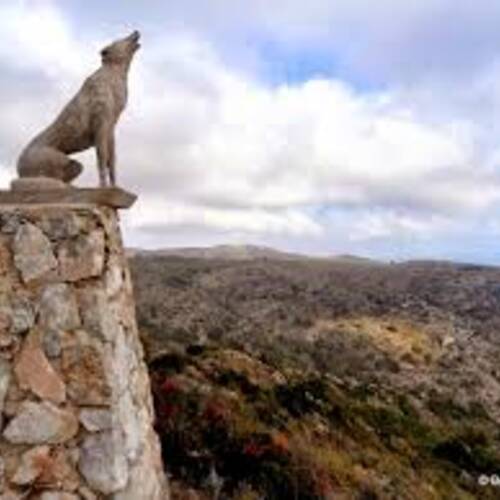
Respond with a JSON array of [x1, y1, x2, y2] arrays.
[[151, 348, 500, 500]]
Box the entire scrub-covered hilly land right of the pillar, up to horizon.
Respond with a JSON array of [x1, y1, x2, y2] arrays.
[[132, 254, 500, 499]]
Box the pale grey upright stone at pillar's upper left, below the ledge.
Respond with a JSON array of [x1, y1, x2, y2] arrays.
[[13, 223, 57, 283]]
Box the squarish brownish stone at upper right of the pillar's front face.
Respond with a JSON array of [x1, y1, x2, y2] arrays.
[[57, 229, 104, 281]]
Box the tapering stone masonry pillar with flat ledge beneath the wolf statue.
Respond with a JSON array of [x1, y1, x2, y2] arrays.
[[0, 189, 168, 500]]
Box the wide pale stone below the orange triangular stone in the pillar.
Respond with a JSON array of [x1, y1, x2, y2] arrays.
[[3, 401, 78, 445]]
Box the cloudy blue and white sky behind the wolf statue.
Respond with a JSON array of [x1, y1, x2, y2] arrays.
[[0, 0, 500, 265]]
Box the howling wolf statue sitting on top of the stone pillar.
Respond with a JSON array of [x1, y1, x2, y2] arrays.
[[17, 31, 140, 187]]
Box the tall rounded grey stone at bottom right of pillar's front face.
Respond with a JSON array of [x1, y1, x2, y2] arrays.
[[79, 432, 128, 495]]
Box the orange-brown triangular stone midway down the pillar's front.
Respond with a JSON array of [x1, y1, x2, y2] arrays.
[[14, 332, 66, 403]]
